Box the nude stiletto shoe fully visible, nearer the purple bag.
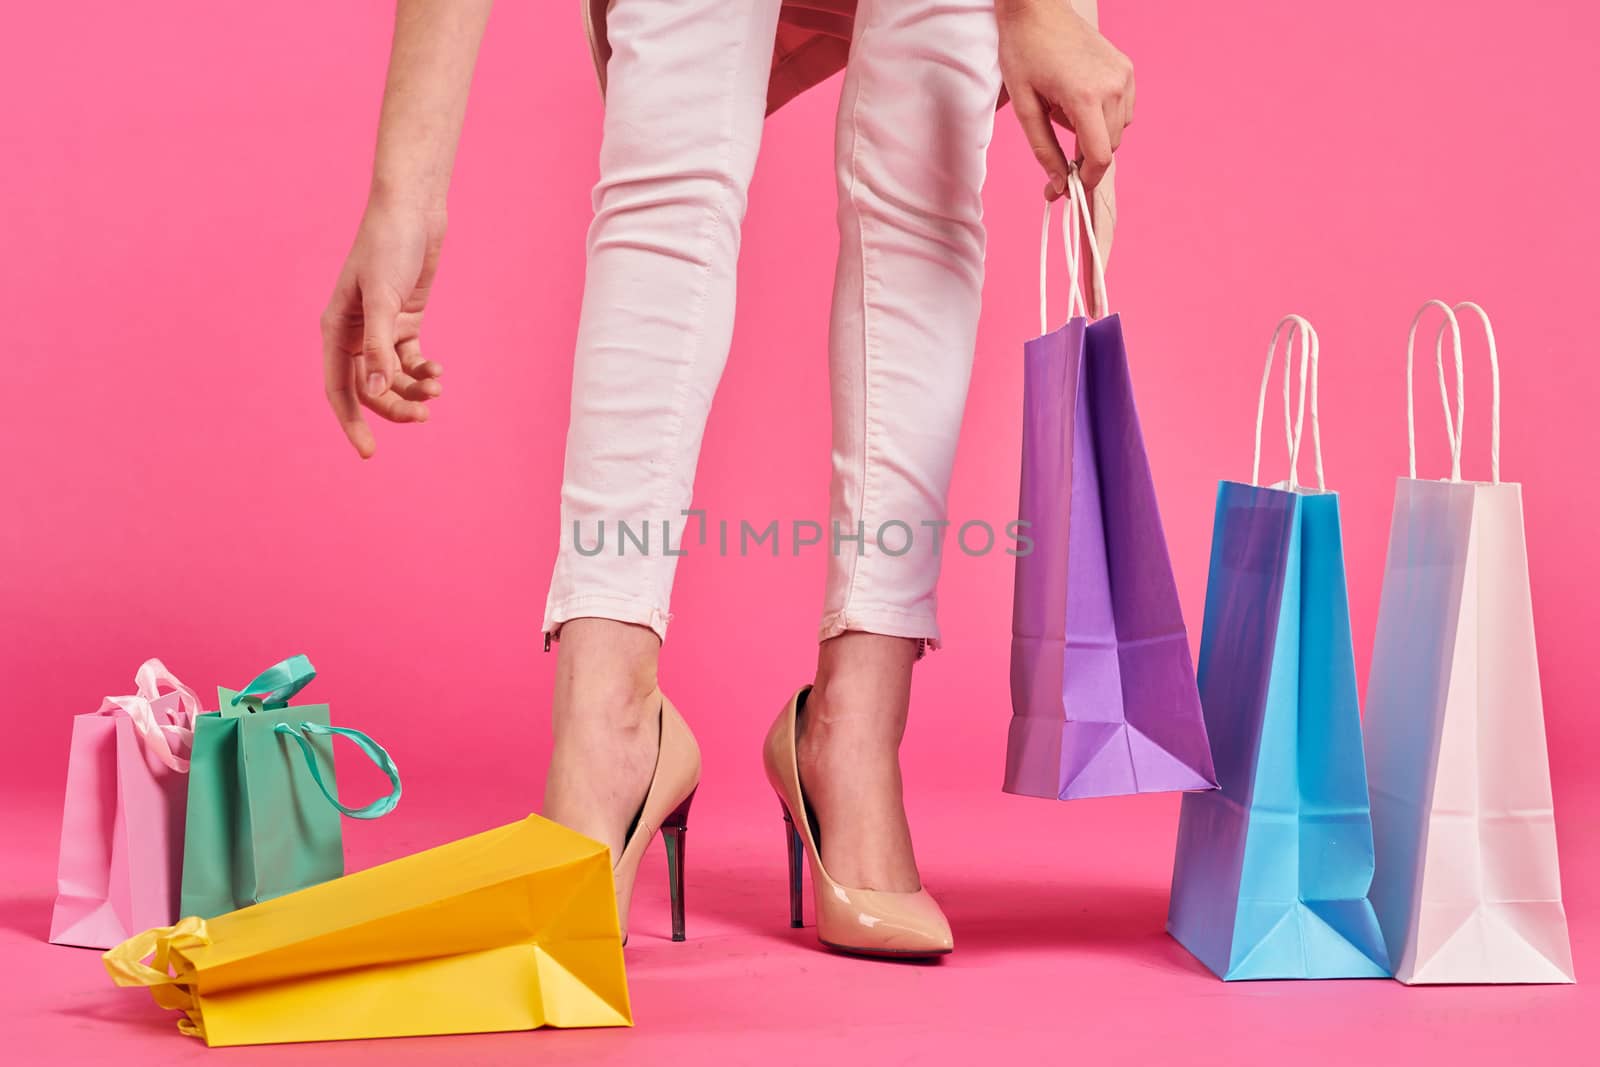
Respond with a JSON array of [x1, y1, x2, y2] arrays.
[[762, 686, 955, 958]]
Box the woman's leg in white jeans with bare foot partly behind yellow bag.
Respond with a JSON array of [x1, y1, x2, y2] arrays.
[[544, 0, 779, 856]]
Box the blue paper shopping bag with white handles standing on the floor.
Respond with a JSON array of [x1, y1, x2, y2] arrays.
[[1166, 315, 1389, 981]]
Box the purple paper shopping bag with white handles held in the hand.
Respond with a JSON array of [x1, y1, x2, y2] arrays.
[[1005, 173, 1216, 800]]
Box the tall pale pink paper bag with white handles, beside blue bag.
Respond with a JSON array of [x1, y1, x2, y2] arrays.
[[1366, 301, 1573, 985]]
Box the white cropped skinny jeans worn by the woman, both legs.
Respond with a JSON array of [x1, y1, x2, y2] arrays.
[[544, 0, 1000, 645]]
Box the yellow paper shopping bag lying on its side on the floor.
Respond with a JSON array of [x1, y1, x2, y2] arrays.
[[106, 816, 634, 1046]]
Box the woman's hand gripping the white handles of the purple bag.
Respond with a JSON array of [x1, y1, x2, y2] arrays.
[[995, 0, 1133, 200]]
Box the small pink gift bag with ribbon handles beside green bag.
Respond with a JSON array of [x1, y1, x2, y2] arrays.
[[50, 659, 200, 949]]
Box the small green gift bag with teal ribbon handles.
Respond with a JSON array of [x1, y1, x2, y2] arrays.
[[179, 656, 400, 918]]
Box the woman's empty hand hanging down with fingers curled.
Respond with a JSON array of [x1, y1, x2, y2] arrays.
[[322, 197, 445, 459]]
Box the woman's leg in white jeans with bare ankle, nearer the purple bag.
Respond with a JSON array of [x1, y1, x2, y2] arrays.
[[800, 0, 1000, 891]]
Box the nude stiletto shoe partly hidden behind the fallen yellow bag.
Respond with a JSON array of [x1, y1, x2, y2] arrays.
[[611, 691, 701, 944]]
